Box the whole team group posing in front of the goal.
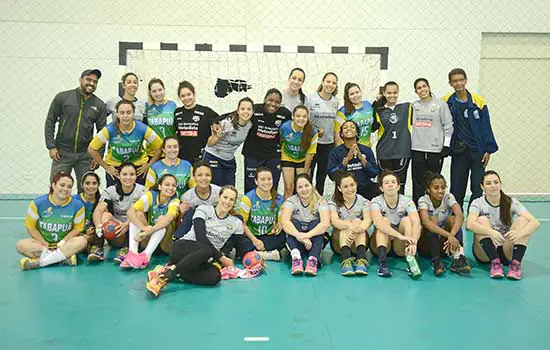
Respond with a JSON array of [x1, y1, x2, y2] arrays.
[[17, 68, 539, 295]]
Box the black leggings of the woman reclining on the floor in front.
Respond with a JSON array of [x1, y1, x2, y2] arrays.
[[169, 239, 222, 286]]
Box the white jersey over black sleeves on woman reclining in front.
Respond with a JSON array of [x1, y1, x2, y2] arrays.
[[183, 205, 244, 250]]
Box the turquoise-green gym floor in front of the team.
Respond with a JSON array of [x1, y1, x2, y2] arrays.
[[0, 201, 550, 350]]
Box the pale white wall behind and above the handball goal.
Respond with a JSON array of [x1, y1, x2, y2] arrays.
[[0, 0, 550, 197]]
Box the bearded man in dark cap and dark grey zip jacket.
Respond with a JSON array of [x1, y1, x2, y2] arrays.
[[45, 69, 107, 192]]
